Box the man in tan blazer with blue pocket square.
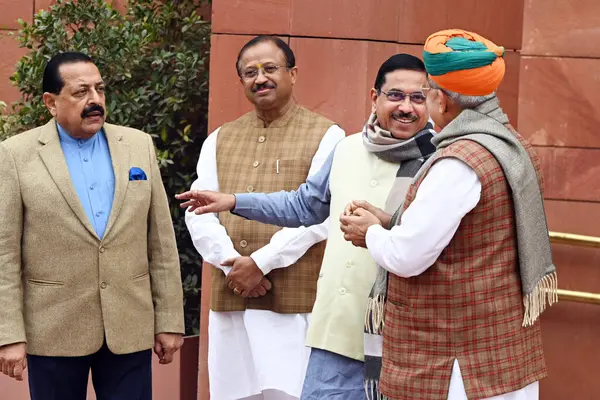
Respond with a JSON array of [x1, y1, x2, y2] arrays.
[[0, 53, 184, 400]]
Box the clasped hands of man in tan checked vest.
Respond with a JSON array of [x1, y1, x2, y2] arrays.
[[221, 257, 271, 297]]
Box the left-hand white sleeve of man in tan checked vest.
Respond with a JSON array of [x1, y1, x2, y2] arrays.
[[185, 129, 240, 275]]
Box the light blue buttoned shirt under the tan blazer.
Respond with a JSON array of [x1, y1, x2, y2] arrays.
[[56, 124, 115, 239]]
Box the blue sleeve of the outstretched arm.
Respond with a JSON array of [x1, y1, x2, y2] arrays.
[[232, 149, 335, 228]]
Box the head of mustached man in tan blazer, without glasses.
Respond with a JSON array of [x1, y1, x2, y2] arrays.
[[44, 62, 106, 139]]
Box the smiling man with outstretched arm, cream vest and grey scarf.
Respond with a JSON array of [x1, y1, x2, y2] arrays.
[[178, 54, 435, 400]]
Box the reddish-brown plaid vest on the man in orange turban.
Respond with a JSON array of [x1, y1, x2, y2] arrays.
[[380, 129, 546, 400]]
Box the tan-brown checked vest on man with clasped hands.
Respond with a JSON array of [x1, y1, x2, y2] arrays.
[[211, 105, 334, 313]]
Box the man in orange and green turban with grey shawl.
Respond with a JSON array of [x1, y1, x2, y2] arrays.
[[340, 30, 556, 400]]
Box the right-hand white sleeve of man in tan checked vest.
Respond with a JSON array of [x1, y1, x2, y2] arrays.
[[250, 125, 345, 275]]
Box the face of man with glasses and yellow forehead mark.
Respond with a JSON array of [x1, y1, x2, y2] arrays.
[[238, 41, 297, 111]]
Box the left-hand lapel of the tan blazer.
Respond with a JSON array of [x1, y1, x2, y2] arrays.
[[38, 119, 98, 238]]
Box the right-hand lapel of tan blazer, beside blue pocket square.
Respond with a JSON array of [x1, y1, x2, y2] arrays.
[[104, 124, 129, 238]]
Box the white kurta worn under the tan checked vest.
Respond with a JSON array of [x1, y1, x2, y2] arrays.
[[185, 125, 345, 400]]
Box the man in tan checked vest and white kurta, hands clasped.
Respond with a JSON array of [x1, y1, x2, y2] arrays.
[[186, 36, 345, 400]]
